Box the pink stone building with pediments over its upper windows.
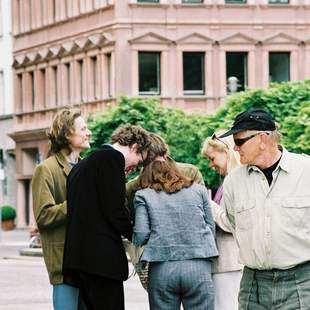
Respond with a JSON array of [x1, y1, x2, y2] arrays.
[[11, 0, 310, 226]]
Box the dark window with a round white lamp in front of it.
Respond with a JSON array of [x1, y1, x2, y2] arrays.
[[226, 52, 248, 94]]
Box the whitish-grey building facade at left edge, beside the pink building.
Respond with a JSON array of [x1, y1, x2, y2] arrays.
[[0, 0, 17, 211]]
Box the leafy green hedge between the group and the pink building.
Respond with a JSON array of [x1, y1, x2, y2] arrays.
[[87, 80, 310, 187]]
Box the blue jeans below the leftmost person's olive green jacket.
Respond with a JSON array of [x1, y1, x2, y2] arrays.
[[53, 284, 79, 310]]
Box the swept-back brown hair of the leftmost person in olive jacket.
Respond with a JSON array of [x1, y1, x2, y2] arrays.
[[47, 109, 81, 156]]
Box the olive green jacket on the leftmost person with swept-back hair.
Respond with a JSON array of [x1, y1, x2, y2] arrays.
[[32, 152, 71, 285]]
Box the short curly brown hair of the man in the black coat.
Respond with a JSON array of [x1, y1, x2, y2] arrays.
[[110, 124, 150, 152]]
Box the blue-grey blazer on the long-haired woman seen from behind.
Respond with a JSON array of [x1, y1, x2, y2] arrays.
[[133, 184, 218, 262]]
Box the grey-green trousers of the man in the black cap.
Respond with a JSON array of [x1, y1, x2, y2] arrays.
[[239, 262, 310, 310]]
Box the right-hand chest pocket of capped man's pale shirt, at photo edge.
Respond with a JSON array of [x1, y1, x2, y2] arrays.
[[281, 196, 310, 230]]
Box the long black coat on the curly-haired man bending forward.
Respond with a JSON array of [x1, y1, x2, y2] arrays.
[[63, 145, 132, 283]]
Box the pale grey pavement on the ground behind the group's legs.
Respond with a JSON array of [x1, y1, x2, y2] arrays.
[[0, 230, 149, 310]]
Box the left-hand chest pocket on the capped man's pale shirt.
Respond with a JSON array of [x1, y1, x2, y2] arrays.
[[235, 199, 255, 230]]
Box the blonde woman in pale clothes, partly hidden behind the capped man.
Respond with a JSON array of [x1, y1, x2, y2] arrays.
[[202, 131, 242, 310]]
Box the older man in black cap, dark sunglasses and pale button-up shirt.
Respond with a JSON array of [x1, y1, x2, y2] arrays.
[[218, 109, 310, 310]]
